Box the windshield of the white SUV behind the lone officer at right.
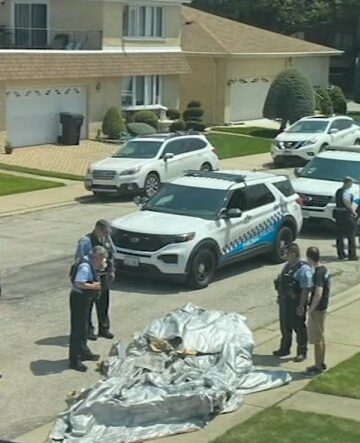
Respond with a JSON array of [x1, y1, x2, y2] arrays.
[[300, 157, 360, 182]]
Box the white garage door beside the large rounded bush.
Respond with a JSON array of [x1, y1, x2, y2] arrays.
[[230, 77, 272, 122]]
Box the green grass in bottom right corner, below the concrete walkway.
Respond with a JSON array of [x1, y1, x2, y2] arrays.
[[213, 408, 360, 443]]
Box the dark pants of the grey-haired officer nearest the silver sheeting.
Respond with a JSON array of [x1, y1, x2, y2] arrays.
[[69, 291, 91, 362]]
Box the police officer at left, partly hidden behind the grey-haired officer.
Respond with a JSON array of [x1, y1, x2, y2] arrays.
[[75, 219, 115, 340]]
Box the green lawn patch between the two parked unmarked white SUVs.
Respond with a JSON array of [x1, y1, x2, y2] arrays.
[[207, 133, 271, 159]]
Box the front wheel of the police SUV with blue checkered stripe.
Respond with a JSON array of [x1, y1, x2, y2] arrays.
[[189, 247, 216, 289]]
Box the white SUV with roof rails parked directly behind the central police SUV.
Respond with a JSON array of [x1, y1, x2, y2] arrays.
[[85, 133, 219, 197]]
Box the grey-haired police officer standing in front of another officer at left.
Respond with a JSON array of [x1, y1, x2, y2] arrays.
[[69, 246, 107, 372]]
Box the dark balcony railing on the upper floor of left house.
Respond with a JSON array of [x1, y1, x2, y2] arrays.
[[0, 26, 102, 50]]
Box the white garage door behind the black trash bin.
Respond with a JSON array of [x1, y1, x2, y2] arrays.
[[6, 86, 86, 147]]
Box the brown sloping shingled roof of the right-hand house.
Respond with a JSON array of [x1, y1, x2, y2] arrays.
[[182, 6, 342, 56]]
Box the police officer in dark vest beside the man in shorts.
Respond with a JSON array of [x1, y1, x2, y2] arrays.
[[273, 243, 313, 362]]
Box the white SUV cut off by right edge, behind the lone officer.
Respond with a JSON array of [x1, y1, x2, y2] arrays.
[[293, 147, 360, 221]]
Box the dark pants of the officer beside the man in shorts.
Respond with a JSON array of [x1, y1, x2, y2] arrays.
[[279, 300, 308, 355]]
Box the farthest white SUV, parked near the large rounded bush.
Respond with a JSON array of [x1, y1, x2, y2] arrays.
[[271, 115, 360, 164]]
